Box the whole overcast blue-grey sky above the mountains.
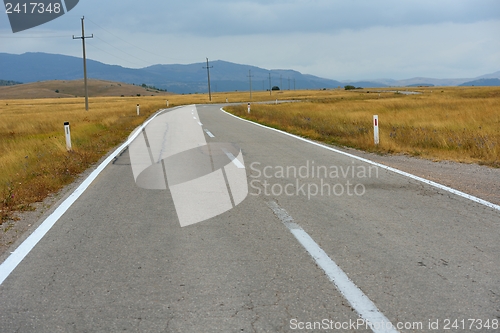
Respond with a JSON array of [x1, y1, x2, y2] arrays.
[[0, 0, 500, 80]]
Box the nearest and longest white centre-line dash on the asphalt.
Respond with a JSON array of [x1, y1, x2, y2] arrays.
[[267, 201, 398, 333]]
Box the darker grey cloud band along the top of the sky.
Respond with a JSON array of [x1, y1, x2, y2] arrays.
[[80, 0, 500, 36]]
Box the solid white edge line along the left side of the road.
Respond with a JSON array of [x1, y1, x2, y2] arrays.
[[0, 109, 170, 285]]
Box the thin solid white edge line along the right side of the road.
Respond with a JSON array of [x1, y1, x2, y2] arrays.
[[220, 108, 500, 211]]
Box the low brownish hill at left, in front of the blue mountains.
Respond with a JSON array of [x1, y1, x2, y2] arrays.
[[0, 79, 168, 99]]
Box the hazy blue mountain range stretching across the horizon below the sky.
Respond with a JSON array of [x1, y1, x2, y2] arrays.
[[0, 53, 500, 93]]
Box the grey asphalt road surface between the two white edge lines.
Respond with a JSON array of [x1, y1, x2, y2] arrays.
[[0, 105, 500, 333]]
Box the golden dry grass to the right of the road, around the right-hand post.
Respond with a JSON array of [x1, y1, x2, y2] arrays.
[[226, 87, 500, 167]]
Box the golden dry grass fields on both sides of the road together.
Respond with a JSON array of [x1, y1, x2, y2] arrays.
[[0, 82, 500, 224]]
